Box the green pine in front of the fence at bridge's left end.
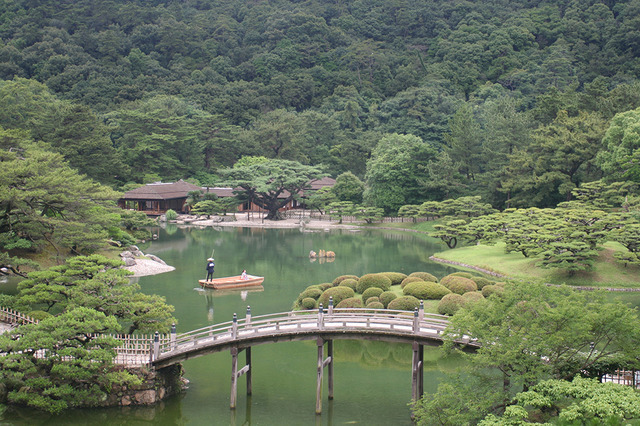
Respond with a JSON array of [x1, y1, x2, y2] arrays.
[[0, 308, 140, 413]]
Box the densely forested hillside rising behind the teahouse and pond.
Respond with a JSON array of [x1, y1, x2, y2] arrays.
[[0, 0, 640, 212]]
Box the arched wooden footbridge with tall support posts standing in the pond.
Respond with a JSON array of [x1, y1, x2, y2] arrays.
[[149, 304, 474, 413]]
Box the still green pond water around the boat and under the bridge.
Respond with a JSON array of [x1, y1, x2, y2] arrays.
[[0, 226, 460, 425]]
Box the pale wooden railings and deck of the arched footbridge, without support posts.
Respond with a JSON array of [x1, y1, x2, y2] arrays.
[[157, 308, 449, 356]]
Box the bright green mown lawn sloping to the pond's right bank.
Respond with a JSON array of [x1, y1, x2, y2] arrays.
[[435, 243, 640, 287]]
